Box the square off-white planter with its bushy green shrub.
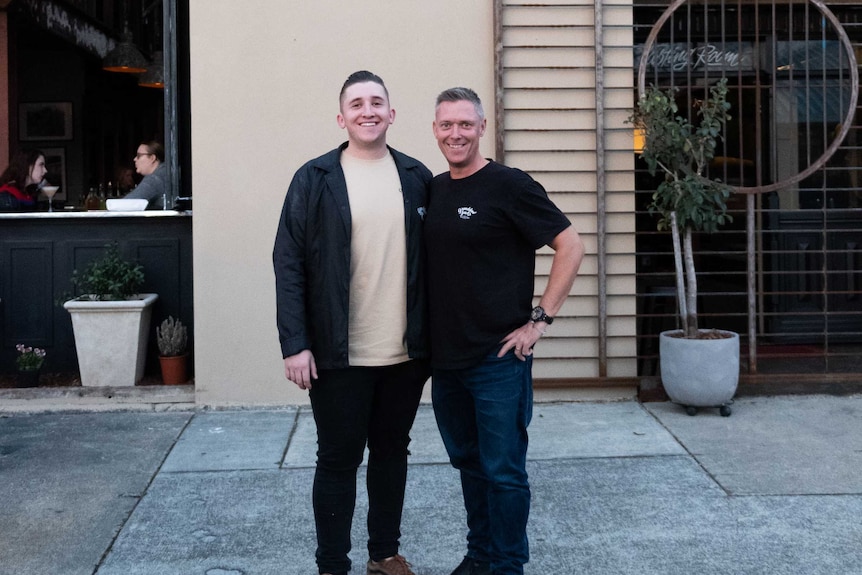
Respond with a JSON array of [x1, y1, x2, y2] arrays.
[[63, 242, 159, 386]]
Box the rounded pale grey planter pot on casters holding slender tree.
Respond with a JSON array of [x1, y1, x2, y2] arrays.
[[659, 330, 739, 415]]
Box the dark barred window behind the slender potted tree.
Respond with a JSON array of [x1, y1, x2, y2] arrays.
[[634, 1, 862, 380]]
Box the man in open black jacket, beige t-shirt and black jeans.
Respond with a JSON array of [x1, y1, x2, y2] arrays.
[[273, 71, 431, 575]]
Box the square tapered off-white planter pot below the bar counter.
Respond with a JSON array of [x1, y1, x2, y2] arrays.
[[63, 294, 159, 387]]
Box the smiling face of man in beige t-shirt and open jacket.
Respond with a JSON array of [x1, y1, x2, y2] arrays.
[[337, 82, 395, 152]]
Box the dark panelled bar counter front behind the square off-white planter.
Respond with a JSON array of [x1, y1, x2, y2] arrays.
[[0, 210, 194, 375]]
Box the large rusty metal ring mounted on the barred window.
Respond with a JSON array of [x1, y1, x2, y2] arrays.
[[638, 0, 859, 194]]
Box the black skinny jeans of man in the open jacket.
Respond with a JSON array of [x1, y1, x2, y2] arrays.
[[309, 360, 430, 574]]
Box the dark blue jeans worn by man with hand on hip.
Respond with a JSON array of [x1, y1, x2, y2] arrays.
[[432, 351, 533, 575]]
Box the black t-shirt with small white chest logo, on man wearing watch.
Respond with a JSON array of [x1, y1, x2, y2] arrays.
[[425, 162, 571, 369]]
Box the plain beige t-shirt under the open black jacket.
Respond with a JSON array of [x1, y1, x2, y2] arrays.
[[341, 154, 409, 367]]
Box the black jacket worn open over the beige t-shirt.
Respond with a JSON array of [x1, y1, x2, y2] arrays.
[[272, 143, 431, 369]]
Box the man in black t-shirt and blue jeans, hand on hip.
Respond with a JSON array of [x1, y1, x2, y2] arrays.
[[425, 88, 584, 575]]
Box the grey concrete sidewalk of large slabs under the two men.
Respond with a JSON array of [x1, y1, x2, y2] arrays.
[[0, 396, 862, 575]]
